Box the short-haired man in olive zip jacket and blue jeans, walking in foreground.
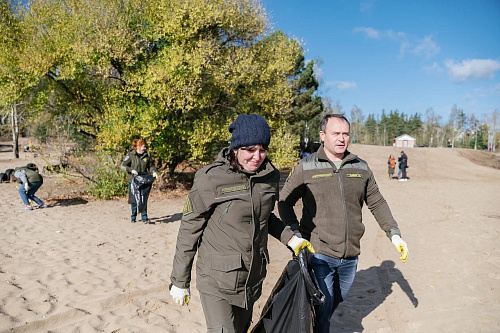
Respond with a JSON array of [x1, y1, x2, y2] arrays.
[[278, 114, 408, 333]]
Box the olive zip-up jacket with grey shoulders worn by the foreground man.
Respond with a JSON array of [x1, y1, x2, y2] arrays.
[[278, 146, 401, 258]]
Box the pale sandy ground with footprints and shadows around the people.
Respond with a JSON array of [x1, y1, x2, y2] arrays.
[[0, 145, 500, 333]]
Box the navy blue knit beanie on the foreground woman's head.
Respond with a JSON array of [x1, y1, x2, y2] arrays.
[[229, 114, 271, 149]]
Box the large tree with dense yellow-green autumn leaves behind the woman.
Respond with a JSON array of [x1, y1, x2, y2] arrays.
[[0, 0, 308, 172]]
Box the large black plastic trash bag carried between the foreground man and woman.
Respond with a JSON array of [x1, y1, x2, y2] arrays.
[[251, 249, 325, 333]]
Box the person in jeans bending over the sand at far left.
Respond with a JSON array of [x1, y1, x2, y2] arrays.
[[14, 163, 47, 210]]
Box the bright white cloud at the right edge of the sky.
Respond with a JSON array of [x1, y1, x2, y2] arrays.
[[445, 59, 500, 82]]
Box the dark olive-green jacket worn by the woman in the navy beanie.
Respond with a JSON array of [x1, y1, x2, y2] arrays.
[[171, 148, 293, 309]]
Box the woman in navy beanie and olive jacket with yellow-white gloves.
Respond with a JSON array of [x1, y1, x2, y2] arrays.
[[170, 114, 314, 333]]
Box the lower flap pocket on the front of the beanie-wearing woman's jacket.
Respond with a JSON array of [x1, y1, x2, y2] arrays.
[[210, 253, 244, 291]]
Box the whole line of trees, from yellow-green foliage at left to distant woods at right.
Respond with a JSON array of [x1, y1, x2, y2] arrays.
[[0, 0, 498, 174]]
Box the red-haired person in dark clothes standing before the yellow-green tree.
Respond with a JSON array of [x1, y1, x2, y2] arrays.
[[121, 139, 157, 223]]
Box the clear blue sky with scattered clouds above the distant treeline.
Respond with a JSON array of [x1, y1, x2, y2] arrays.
[[261, 0, 500, 123]]
